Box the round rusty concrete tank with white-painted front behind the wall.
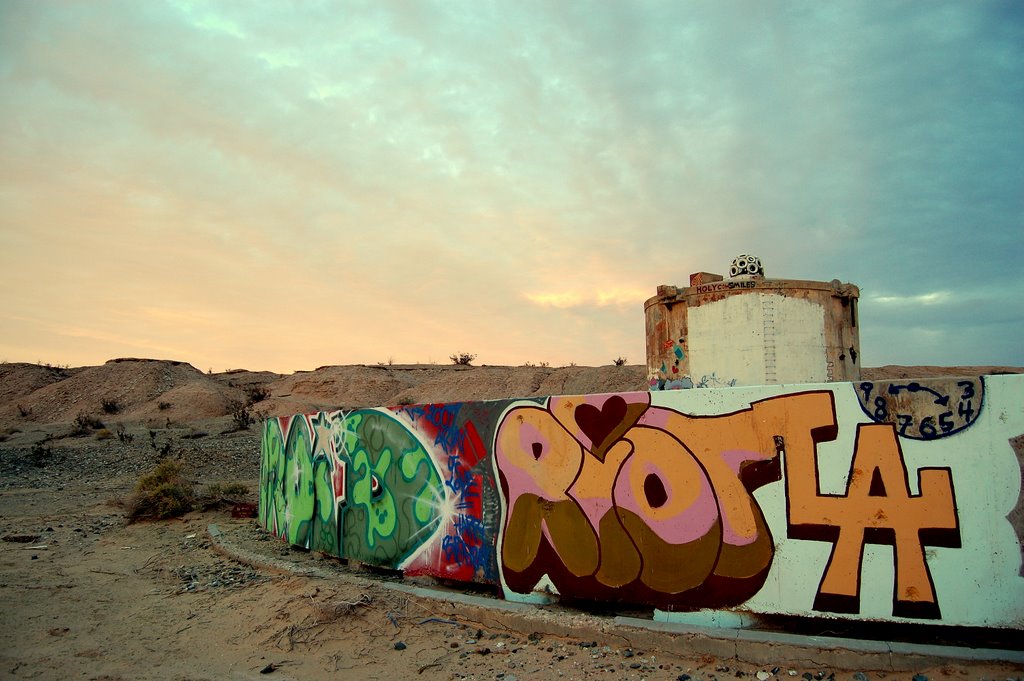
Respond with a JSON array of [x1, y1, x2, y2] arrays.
[[644, 255, 860, 390]]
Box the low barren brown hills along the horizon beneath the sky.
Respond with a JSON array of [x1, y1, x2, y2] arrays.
[[0, 358, 1024, 428]]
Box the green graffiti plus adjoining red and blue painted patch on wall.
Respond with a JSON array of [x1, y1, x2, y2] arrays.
[[259, 406, 495, 581]]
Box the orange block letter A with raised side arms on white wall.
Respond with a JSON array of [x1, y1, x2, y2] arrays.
[[785, 424, 961, 619]]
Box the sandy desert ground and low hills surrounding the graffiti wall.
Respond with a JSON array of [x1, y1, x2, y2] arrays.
[[0, 359, 1024, 681]]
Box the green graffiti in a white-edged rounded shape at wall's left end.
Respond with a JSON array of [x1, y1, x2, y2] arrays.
[[259, 410, 444, 566]]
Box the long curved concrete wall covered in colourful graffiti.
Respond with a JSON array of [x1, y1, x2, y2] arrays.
[[259, 376, 1024, 628]]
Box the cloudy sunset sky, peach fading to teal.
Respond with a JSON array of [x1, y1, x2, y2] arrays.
[[0, 0, 1024, 373]]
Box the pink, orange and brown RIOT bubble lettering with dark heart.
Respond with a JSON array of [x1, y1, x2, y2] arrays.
[[495, 393, 806, 608]]
